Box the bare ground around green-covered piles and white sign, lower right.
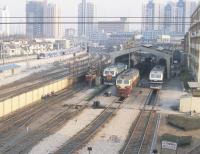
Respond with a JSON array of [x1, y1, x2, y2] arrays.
[[157, 78, 200, 154]]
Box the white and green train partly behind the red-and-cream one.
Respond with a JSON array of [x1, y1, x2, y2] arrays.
[[103, 63, 127, 85]]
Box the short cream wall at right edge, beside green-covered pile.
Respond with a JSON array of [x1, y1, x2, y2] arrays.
[[179, 96, 200, 113]]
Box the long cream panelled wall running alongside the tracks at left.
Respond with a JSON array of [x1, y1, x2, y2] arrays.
[[0, 78, 75, 117]]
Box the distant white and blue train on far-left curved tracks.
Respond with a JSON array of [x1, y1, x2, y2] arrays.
[[37, 47, 83, 59]]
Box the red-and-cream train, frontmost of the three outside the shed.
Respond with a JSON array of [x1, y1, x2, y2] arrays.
[[116, 69, 140, 97]]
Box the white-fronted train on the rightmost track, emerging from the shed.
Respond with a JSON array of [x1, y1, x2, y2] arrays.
[[149, 65, 165, 89]]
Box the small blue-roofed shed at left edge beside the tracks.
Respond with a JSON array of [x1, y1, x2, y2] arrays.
[[0, 64, 20, 78]]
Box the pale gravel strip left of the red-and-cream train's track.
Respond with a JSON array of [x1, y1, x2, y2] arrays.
[[29, 109, 103, 154]]
